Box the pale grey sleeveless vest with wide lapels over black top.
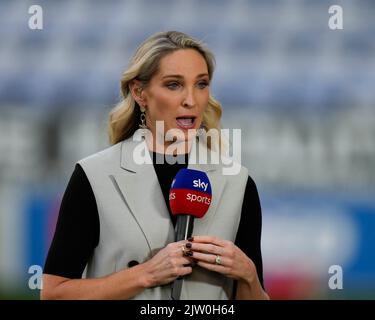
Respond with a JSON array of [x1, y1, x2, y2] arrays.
[[78, 138, 248, 300]]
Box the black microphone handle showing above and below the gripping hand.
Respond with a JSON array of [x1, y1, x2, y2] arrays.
[[171, 214, 194, 300]]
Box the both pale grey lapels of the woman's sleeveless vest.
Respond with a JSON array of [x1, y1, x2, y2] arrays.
[[114, 138, 226, 252]]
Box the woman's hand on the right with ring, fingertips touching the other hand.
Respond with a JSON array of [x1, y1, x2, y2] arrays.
[[185, 236, 257, 283]]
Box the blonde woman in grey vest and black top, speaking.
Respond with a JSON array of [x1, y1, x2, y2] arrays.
[[41, 31, 268, 299]]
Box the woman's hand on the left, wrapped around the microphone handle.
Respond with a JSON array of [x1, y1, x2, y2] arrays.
[[143, 240, 193, 288]]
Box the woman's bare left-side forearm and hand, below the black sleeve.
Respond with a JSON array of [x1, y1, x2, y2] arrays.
[[41, 240, 192, 300]]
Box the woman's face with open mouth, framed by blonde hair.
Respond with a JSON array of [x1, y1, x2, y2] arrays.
[[136, 49, 209, 149]]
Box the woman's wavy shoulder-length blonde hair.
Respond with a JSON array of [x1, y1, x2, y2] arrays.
[[108, 31, 222, 148]]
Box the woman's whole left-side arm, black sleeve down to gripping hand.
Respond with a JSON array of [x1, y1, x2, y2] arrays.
[[41, 165, 192, 299]]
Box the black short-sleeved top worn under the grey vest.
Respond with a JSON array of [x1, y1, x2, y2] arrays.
[[44, 153, 264, 296]]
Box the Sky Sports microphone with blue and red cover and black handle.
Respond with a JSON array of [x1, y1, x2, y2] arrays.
[[169, 169, 212, 300]]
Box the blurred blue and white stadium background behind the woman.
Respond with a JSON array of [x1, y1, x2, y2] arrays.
[[0, 0, 375, 299]]
